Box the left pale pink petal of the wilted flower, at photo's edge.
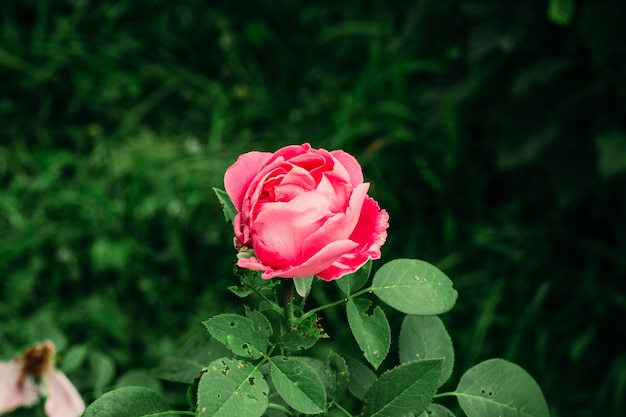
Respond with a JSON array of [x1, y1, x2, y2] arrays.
[[0, 359, 39, 414]]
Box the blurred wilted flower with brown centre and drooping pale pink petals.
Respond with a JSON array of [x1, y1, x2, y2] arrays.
[[0, 341, 85, 417]]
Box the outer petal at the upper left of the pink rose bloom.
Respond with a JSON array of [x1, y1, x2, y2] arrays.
[[224, 152, 272, 211]]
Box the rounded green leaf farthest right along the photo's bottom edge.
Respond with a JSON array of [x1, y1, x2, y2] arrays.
[[456, 359, 550, 417]]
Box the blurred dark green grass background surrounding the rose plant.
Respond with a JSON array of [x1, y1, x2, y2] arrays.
[[0, 0, 626, 417]]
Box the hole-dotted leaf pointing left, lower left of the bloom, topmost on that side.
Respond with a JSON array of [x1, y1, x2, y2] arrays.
[[202, 314, 268, 359]]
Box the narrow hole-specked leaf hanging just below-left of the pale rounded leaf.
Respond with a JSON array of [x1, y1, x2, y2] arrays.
[[346, 299, 391, 369]]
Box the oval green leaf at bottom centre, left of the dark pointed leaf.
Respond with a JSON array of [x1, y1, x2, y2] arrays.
[[270, 356, 326, 414]]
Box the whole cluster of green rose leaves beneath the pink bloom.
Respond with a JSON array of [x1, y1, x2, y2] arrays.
[[85, 250, 549, 417]]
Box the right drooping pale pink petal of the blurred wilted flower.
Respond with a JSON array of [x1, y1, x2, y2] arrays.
[[42, 371, 85, 417]]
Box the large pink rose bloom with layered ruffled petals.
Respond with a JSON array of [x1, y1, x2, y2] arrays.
[[224, 143, 389, 281]]
